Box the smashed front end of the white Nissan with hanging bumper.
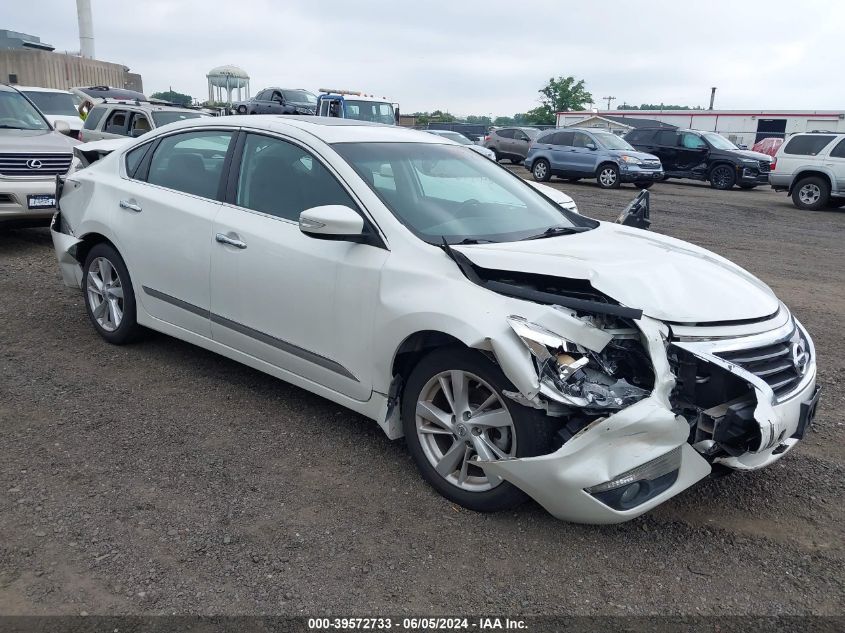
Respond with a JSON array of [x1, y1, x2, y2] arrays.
[[442, 244, 817, 523]]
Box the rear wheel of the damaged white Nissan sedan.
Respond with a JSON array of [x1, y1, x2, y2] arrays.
[[82, 243, 141, 345]]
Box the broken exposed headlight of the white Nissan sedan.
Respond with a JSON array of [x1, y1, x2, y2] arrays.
[[508, 316, 654, 410]]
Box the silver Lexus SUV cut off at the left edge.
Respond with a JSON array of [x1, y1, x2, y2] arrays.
[[0, 84, 77, 228]]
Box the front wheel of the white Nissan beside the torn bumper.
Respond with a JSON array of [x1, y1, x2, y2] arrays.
[[402, 347, 554, 512]]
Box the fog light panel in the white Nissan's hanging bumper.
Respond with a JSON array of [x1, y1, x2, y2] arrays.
[[584, 446, 681, 510]]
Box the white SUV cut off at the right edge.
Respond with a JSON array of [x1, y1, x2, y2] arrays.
[[769, 132, 845, 211]]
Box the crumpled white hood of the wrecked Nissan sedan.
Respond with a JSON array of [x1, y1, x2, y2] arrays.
[[452, 222, 779, 323]]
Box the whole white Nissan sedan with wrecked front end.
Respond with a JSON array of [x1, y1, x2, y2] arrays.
[[52, 116, 818, 523]]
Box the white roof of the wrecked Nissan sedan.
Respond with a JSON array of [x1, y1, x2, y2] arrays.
[[146, 114, 452, 144]]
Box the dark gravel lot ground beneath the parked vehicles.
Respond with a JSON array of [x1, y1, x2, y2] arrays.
[[0, 171, 845, 615]]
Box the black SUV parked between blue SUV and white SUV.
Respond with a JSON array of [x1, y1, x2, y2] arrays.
[[625, 128, 772, 189]]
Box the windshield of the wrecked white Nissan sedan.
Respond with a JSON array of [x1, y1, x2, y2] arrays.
[[333, 143, 597, 244]]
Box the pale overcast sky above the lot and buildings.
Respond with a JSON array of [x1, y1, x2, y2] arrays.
[[6, 0, 845, 116]]
